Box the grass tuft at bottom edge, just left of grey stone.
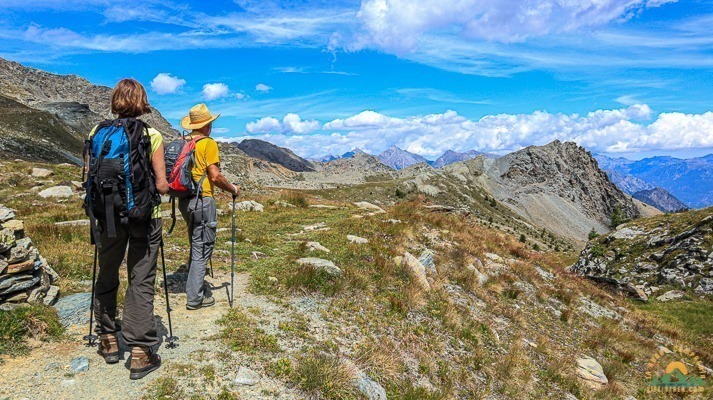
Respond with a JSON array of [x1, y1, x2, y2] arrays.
[[292, 352, 359, 400]]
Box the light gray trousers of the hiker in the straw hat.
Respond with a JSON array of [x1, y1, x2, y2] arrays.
[[178, 197, 218, 306]]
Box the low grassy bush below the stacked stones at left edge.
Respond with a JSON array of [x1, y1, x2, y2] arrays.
[[0, 304, 64, 355]]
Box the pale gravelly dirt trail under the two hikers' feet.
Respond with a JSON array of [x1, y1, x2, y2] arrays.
[[0, 270, 298, 399]]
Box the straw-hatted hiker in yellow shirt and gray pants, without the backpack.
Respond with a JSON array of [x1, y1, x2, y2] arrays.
[[178, 103, 240, 310]]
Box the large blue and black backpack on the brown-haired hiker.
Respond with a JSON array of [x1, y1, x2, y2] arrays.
[[84, 118, 161, 245]]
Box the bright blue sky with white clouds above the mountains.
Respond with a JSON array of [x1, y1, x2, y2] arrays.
[[0, 0, 713, 159]]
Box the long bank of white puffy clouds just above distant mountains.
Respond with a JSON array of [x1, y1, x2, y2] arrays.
[[238, 104, 713, 158]]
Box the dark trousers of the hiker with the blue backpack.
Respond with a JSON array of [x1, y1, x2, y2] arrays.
[[94, 219, 162, 346]]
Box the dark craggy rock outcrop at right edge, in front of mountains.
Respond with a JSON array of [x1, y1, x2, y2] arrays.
[[570, 208, 713, 297]]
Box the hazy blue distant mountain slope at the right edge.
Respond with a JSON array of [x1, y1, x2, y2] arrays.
[[597, 155, 713, 208]]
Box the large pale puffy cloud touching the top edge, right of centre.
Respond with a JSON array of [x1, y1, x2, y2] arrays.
[[356, 0, 675, 54]]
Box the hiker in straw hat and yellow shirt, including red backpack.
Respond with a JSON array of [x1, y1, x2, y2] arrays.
[[166, 103, 240, 310]]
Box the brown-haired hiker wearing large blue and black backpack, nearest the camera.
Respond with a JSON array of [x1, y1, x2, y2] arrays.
[[84, 79, 170, 379]]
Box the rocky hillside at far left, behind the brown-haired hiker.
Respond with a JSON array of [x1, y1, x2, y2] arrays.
[[0, 58, 178, 161]]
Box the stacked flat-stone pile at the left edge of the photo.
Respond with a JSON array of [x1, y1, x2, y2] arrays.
[[0, 205, 59, 304]]
